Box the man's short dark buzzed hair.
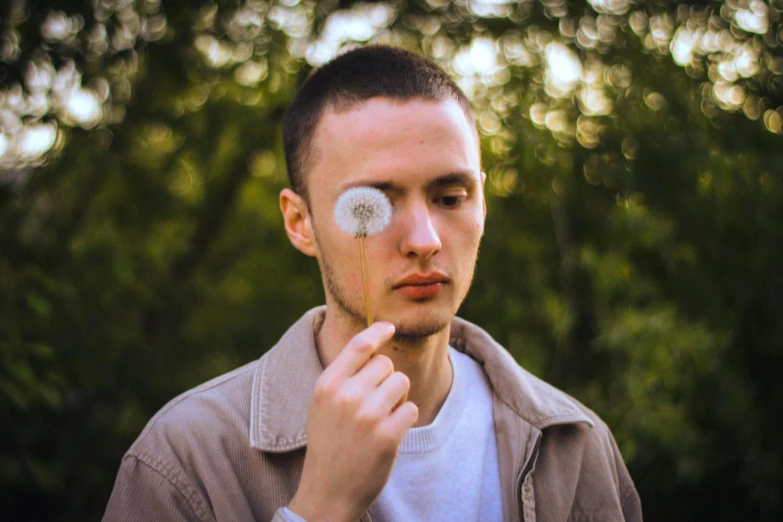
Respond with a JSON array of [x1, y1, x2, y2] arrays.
[[283, 45, 474, 204]]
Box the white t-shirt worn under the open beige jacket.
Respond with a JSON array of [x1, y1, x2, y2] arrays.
[[370, 348, 503, 522]]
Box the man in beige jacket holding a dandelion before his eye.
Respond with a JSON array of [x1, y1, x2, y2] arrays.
[[105, 46, 641, 522]]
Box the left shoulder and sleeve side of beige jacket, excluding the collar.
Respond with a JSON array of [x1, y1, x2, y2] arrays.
[[106, 350, 310, 520]]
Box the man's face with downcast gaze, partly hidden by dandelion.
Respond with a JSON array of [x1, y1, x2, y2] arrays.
[[298, 98, 485, 338]]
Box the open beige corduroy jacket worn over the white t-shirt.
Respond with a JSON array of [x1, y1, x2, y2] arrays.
[[104, 307, 642, 522]]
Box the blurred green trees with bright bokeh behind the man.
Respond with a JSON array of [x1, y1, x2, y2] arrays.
[[0, 0, 783, 521]]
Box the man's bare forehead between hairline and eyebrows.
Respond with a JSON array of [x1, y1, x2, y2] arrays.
[[308, 98, 480, 193]]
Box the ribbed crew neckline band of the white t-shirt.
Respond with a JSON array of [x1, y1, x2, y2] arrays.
[[399, 346, 468, 453]]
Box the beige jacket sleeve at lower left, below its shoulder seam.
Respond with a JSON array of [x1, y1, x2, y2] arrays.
[[103, 455, 214, 522]]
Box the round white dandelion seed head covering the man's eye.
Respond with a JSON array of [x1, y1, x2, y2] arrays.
[[334, 187, 392, 237]]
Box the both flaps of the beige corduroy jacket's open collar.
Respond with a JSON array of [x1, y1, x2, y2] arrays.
[[250, 306, 593, 453]]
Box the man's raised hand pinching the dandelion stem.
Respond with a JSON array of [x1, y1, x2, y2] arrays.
[[288, 322, 419, 522]]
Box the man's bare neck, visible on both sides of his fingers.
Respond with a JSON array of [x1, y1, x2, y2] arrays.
[[315, 309, 453, 427]]
